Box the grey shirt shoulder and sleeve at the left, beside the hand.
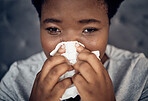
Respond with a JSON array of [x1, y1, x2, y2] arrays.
[[0, 52, 46, 101]]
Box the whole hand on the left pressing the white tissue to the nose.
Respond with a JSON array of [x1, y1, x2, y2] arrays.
[[29, 45, 72, 101]]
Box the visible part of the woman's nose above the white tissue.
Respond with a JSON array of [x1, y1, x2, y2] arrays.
[[61, 30, 80, 41]]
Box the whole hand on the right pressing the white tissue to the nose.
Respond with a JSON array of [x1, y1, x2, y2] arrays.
[[72, 45, 115, 101]]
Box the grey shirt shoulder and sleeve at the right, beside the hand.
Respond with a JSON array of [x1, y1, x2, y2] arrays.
[[106, 45, 148, 101]]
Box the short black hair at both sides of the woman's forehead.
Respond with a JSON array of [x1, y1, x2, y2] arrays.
[[32, 0, 124, 22]]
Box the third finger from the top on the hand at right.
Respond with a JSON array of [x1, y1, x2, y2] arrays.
[[73, 61, 96, 83]]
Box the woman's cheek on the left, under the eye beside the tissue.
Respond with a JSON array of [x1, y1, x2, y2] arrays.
[[40, 30, 60, 58]]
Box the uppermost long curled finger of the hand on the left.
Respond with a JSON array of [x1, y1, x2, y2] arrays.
[[40, 56, 69, 81]]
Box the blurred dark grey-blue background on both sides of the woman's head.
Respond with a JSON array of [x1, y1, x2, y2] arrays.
[[0, 0, 148, 80]]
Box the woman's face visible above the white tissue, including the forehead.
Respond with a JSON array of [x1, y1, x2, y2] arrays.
[[41, 0, 109, 58]]
